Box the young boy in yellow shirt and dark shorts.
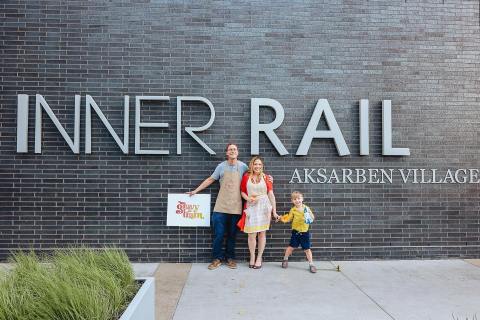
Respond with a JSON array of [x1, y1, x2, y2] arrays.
[[280, 191, 317, 273]]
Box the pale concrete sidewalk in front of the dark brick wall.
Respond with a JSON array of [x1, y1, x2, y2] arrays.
[[142, 260, 480, 320]]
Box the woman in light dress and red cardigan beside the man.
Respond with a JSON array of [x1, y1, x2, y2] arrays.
[[240, 156, 278, 269]]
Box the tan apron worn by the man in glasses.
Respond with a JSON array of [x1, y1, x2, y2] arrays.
[[213, 165, 242, 214]]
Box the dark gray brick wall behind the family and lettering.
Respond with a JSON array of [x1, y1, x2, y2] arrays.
[[0, 0, 480, 262]]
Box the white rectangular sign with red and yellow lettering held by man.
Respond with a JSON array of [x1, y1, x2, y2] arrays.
[[167, 193, 210, 227]]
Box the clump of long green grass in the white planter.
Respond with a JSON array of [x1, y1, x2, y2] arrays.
[[0, 248, 138, 320]]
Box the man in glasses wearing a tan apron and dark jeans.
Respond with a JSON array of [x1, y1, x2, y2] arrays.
[[187, 143, 248, 270]]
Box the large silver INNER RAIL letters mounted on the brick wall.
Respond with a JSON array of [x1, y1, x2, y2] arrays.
[[17, 94, 410, 156]]
